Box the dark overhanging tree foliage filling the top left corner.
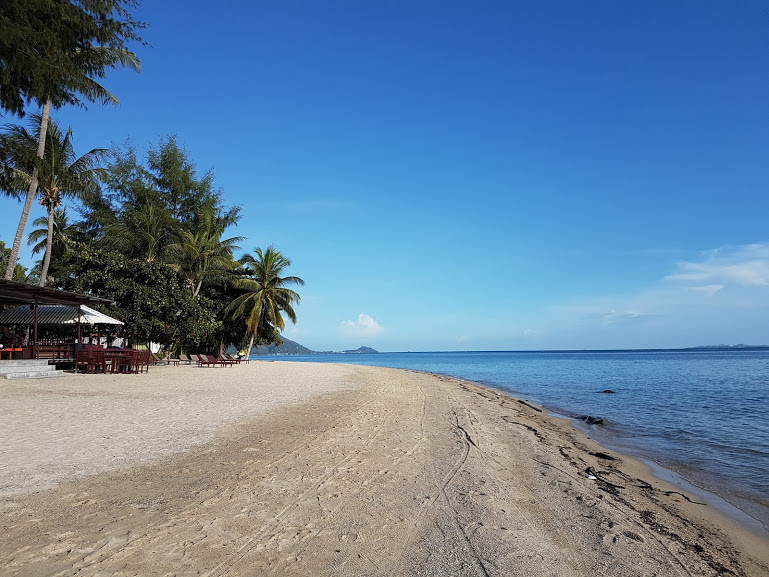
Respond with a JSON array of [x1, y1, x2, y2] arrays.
[[0, 0, 145, 116]]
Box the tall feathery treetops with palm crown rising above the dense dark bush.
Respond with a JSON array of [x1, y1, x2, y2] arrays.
[[83, 136, 240, 276]]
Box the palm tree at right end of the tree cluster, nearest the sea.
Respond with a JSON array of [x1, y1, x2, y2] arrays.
[[225, 246, 304, 357]]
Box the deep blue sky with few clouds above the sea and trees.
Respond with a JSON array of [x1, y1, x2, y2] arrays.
[[0, 0, 769, 351]]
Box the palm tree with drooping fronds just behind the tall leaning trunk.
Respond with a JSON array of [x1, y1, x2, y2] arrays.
[[5, 114, 108, 286]]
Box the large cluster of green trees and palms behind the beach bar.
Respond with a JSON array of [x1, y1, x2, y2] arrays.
[[0, 129, 303, 352]]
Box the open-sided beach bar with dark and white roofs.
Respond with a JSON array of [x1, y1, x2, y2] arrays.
[[0, 279, 115, 359]]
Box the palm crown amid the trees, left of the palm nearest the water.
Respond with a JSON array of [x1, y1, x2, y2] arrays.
[[168, 208, 243, 296]]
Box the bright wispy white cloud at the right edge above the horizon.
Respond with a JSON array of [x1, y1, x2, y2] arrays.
[[665, 244, 769, 294]]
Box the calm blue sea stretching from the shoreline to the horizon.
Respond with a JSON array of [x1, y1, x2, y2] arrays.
[[260, 349, 769, 527]]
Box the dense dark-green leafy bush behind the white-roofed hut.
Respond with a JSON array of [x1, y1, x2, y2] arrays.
[[63, 243, 221, 350]]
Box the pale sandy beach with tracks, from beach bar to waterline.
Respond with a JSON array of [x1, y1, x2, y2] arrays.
[[0, 362, 769, 577]]
